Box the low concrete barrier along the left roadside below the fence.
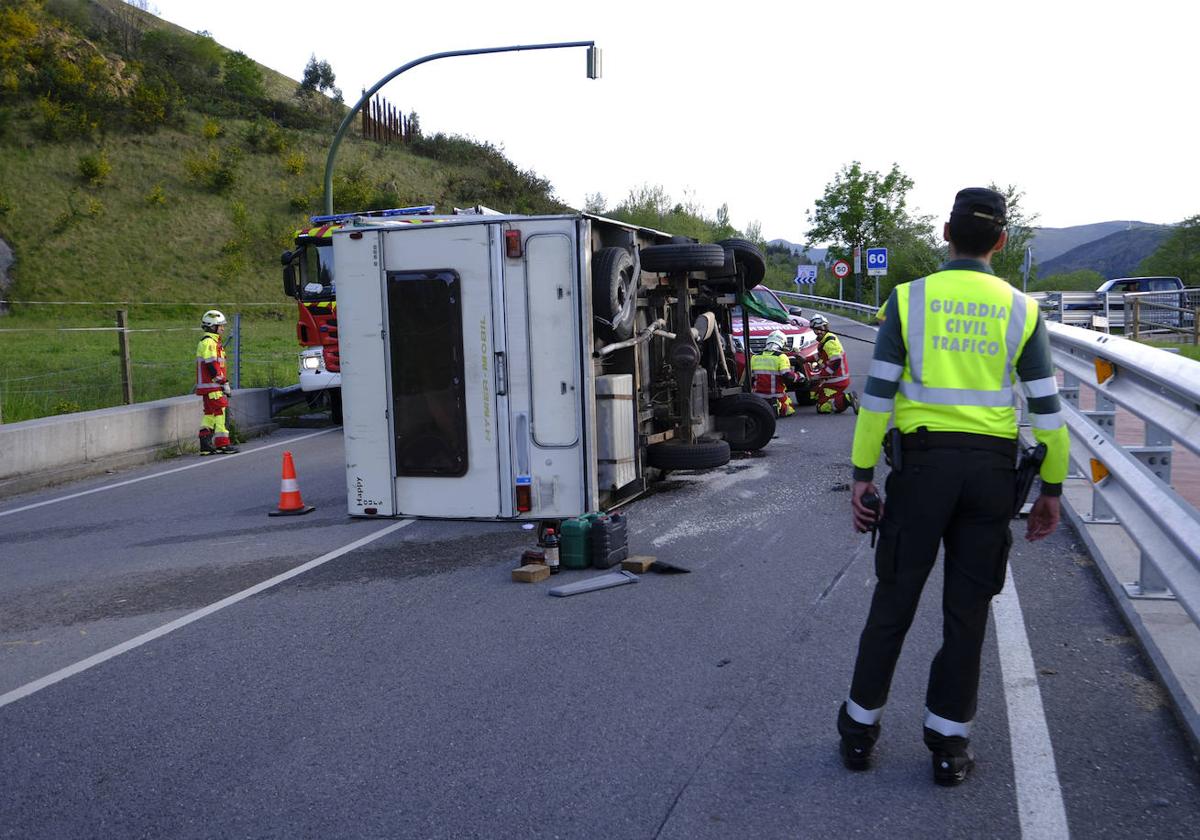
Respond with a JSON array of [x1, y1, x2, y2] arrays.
[[0, 388, 274, 497]]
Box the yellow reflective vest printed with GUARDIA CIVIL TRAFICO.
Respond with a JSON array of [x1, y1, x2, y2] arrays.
[[897, 270, 1040, 437]]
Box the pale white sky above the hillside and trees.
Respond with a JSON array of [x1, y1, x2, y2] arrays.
[[150, 0, 1200, 242]]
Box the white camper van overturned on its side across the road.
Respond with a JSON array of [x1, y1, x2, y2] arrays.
[[312, 214, 775, 523]]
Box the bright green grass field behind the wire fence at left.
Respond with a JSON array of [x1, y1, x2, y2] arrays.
[[0, 307, 299, 422]]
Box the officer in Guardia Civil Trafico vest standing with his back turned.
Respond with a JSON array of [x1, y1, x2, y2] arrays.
[[838, 187, 1068, 785]]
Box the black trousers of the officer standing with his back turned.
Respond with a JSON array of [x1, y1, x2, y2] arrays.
[[839, 444, 1016, 752]]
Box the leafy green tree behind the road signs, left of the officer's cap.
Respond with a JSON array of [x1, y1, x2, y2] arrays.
[[804, 161, 940, 300]]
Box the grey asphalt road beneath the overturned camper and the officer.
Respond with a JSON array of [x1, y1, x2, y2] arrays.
[[0, 316, 1200, 838]]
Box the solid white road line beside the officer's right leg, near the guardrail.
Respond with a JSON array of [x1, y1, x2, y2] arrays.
[[991, 568, 1070, 840]]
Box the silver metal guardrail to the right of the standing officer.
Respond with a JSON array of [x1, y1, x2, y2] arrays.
[[1046, 323, 1200, 625]]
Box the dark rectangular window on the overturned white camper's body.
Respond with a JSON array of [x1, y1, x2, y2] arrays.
[[388, 270, 468, 476]]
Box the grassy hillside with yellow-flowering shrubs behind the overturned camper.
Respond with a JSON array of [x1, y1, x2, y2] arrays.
[[0, 0, 565, 311]]
